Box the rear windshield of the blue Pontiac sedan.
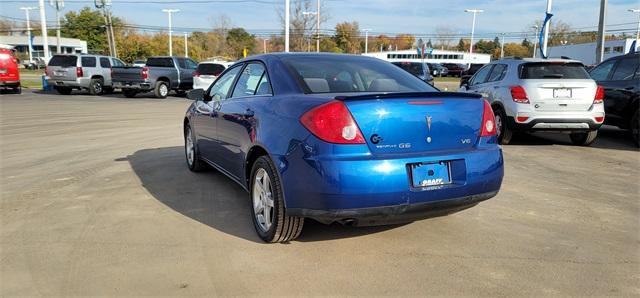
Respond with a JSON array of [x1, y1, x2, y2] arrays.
[[281, 55, 437, 93]]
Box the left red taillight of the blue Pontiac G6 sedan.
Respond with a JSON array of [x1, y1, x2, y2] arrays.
[[300, 100, 365, 144]]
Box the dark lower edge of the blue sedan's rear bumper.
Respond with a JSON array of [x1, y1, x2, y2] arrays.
[[287, 191, 498, 226]]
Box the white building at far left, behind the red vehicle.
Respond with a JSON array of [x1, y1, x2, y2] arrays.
[[0, 35, 87, 58]]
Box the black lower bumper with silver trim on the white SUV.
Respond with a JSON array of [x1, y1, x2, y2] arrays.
[[507, 117, 602, 131]]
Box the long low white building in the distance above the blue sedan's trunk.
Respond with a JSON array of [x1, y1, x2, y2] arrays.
[[362, 49, 491, 64]]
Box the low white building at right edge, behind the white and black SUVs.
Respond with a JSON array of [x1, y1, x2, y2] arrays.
[[547, 38, 638, 65]]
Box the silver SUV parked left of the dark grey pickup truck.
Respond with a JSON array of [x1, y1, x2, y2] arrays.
[[45, 54, 125, 95]]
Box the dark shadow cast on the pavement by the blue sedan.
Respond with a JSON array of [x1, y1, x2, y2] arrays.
[[126, 147, 398, 243]]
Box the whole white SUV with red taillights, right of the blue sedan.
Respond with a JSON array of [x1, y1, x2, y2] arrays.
[[460, 58, 604, 146]]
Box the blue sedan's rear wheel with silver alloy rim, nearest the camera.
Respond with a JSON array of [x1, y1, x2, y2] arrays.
[[249, 156, 304, 243]]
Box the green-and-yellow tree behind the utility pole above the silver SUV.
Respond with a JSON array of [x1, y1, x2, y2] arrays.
[[60, 7, 122, 54]]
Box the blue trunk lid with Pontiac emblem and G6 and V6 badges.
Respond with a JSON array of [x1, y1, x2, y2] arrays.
[[338, 92, 483, 154]]
